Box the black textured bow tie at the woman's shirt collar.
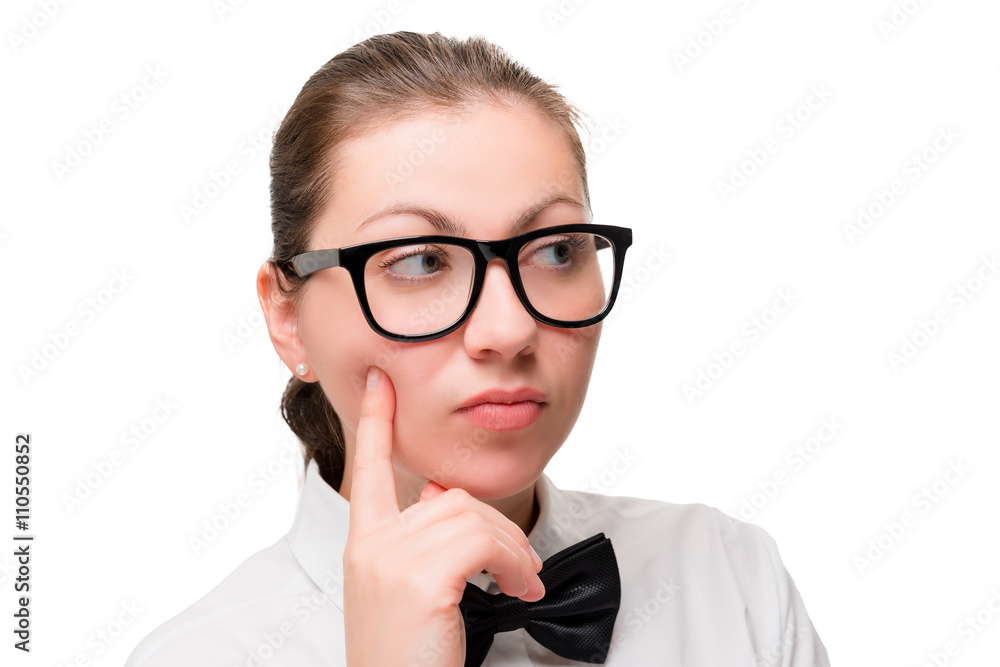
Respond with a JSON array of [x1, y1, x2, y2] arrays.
[[458, 533, 622, 667]]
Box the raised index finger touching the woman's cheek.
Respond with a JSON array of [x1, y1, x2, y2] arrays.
[[348, 366, 399, 536]]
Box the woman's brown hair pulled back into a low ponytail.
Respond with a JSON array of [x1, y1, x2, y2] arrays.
[[268, 31, 590, 491]]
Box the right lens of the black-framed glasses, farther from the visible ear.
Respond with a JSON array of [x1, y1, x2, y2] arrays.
[[517, 232, 615, 322]]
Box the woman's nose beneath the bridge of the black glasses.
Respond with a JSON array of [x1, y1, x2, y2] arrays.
[[463, 259, 538, 360]]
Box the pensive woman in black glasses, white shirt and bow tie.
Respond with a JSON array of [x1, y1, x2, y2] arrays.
[[129, 32, 828, 667]]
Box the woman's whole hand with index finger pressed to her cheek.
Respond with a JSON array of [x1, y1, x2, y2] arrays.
[[344, 368, 545, 667]]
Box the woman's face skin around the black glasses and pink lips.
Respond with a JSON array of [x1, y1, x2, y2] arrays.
[[262, 105, 601, 499]]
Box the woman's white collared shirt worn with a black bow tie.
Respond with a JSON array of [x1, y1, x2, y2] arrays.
[[126, 461, 829, 667]]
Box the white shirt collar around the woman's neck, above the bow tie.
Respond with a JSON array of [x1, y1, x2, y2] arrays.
[[288, 460, 585, 611]]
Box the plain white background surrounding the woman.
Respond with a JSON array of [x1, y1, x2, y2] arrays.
[[0, 0, 1000, 665]]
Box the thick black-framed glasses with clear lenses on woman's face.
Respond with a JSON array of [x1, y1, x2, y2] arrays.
[[281, 223, 632, 343]]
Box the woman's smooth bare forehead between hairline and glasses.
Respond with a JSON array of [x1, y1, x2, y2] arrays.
[[310, 104, 589, 248]]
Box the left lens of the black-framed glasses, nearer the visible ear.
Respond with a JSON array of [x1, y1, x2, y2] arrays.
[[365, 243, 476, 336]]
